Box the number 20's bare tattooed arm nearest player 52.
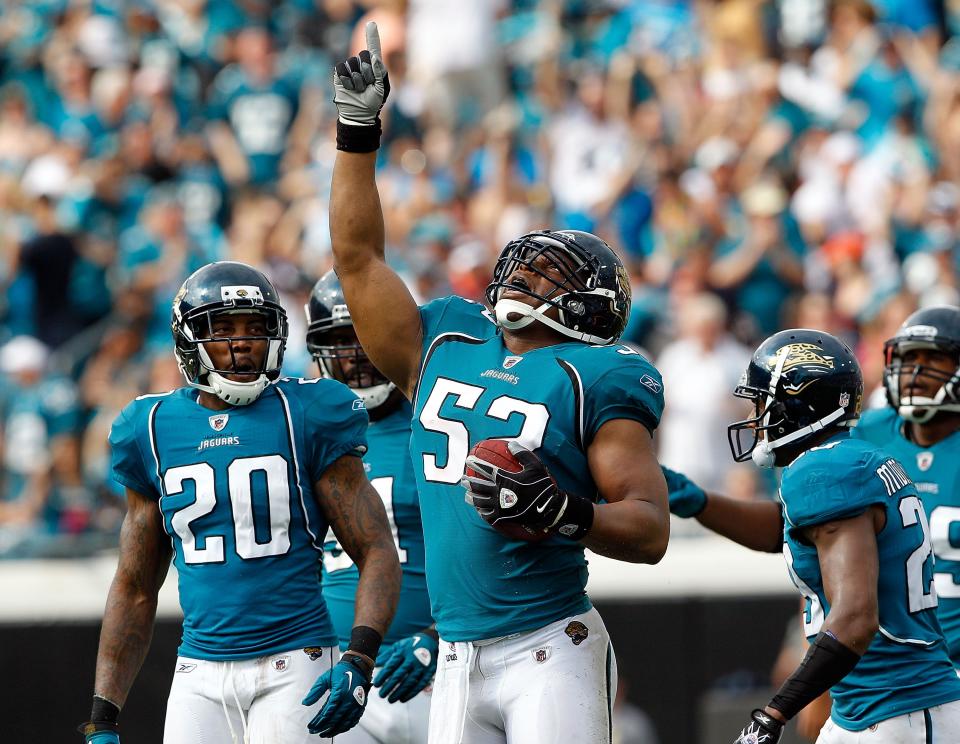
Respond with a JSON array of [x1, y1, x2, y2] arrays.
[[316, 455, 400, 635]]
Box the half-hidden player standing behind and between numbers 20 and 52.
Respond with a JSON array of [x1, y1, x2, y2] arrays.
[[306, 271, 438, 744]]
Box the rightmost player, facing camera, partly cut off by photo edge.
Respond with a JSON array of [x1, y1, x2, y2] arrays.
[[853, 305, 960, 668]]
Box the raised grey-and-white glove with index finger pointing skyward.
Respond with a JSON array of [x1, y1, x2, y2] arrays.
[[333, 21, 390, 126]]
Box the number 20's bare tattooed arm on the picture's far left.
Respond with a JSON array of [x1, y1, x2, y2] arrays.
[[84, 488, 172, 736]]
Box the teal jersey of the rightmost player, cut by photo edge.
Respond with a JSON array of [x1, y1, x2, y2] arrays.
[[853, 408, 960, 668]]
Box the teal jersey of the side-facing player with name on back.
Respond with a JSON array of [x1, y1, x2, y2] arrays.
[[780, 433, 960, 731]]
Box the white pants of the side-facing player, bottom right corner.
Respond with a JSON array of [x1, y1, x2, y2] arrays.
[[816, 700, 960, 744]]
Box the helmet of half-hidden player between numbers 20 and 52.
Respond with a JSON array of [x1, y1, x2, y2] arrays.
[[303, 271, 394, 410]]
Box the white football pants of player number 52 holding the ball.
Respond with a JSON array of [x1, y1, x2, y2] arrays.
[[429, 609, 617, 744]]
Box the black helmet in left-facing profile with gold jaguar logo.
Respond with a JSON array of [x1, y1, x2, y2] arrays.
[[727, 328, 863, 468]]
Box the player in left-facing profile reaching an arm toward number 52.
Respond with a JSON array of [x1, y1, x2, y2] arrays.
[[665, 329, 960, 744]]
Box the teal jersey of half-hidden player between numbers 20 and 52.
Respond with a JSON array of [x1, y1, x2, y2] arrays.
[[323, 401, 433, 648]]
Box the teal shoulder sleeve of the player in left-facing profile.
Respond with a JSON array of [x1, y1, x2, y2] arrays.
[[780, 441, 888, 528]]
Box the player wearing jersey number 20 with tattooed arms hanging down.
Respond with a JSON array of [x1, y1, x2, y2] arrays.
[[82, 262, 400, 744]]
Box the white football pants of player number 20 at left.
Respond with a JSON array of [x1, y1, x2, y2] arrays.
[[163, 648, 340, 744]]
